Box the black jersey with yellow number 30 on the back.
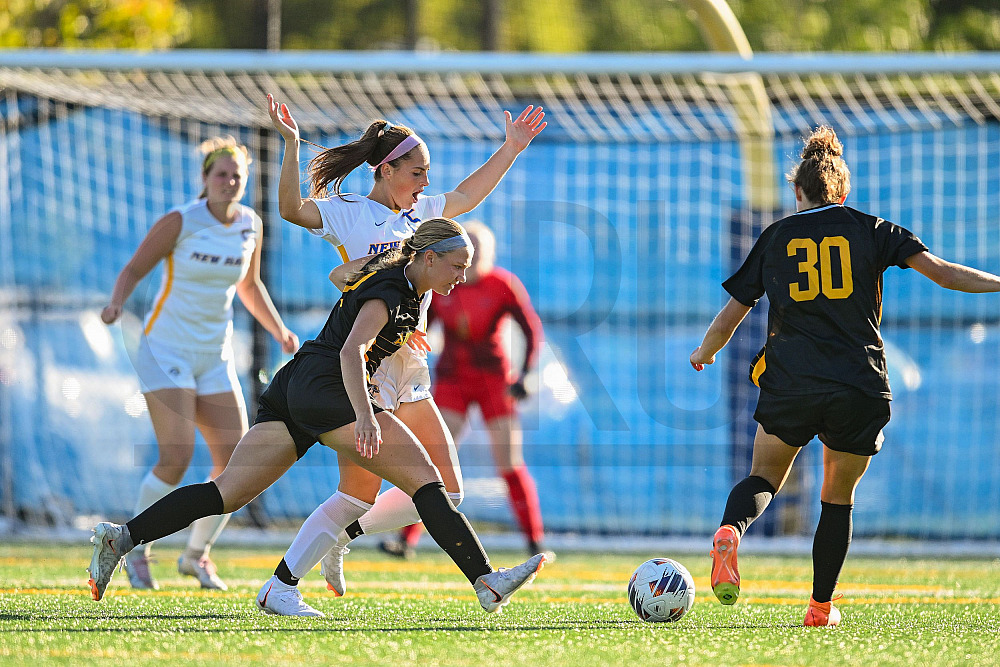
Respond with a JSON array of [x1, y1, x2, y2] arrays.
[[722, 204, 927, 398]]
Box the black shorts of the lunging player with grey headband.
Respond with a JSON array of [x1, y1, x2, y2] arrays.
[[253, 354, 382, 458]]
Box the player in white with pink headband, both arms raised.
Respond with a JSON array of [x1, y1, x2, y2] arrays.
[[254, 95, 546, 613]]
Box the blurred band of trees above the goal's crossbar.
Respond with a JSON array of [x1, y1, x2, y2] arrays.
[[0, 0, 1000, 53]]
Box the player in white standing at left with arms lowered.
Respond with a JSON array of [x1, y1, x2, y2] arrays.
[[101, 137, 299, 590]]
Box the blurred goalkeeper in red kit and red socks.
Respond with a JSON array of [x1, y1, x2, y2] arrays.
[[381, 222, 551, 559]]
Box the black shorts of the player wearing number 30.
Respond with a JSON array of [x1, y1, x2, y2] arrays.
[[753, 387, 890, 456]]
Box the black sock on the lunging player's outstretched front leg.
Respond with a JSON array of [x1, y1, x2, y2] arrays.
[[410, 482, 493, 584]]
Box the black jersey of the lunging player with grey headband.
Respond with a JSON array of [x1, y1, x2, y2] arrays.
[[300, 266, 420, 379]]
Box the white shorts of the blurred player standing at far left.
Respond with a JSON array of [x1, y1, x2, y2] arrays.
[[135, 336, 243, 399]]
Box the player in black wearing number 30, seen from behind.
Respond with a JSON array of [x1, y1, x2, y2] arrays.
[[691, 127, 1000, 626]]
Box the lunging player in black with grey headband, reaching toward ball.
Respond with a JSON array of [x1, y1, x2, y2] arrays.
[[90, 218, 545, 616]]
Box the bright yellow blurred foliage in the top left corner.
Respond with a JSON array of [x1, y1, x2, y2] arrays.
[[0, 0, 190, 49]]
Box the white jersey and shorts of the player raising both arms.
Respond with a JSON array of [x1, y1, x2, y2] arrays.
[[309, 194, 447, 410]]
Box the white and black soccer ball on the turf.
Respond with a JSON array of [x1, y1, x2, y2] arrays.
[[628, 558, 694, 623]]
